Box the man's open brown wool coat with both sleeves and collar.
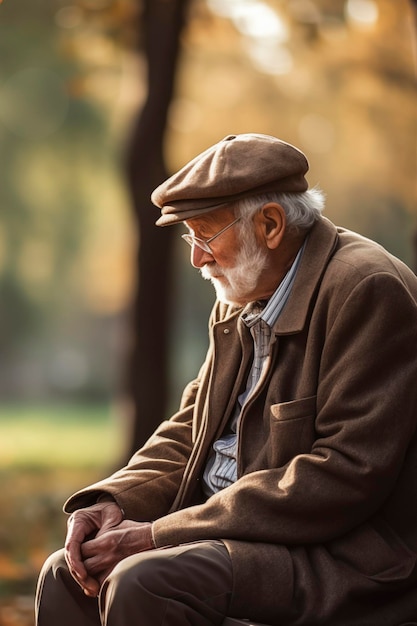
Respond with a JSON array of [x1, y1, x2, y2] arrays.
[[65, 218, 417, 626]]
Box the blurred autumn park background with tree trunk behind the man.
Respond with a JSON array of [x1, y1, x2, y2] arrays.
[[0, 0, 417, 626]]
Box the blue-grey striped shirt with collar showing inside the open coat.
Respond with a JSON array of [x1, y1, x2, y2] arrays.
[[203, 241, 304, 497]]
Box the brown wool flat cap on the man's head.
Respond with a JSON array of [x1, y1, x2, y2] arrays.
[[151, 133, 308, 226]]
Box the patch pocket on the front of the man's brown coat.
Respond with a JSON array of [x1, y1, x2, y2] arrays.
[[269, 396, 316, 467]]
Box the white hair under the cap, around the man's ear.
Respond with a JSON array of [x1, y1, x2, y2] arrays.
[[235, 187, 325, 232]]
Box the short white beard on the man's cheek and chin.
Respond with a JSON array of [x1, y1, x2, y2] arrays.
[[200, 231, 267, 305]]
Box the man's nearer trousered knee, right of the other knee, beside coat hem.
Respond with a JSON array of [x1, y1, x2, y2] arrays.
[[100, 542, 232, 626]]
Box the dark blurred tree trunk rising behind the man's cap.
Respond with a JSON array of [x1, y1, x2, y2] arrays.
[[122, 0, 187, 456]]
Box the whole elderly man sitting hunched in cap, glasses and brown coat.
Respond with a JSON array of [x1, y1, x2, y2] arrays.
[[37, 134, 417, 626]]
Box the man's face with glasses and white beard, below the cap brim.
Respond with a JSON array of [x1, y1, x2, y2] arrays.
[[186, 210, 268, 306]]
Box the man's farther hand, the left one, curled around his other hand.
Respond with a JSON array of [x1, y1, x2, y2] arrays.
[[65, 502, 123, 597]]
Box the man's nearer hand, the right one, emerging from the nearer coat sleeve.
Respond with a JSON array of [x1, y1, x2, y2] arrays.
[[81, 520, 154, 595]]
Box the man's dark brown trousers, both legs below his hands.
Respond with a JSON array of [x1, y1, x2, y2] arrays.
[[36, 541, 233, 626]]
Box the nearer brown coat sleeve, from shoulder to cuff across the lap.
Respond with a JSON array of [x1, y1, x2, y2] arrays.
[[154, 272, 417, 545]]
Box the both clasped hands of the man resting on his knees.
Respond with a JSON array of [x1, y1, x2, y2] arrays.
[[65, 501, 154, 597]]
